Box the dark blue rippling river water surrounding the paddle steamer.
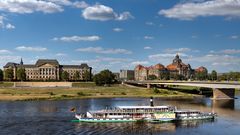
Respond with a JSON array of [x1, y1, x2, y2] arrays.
[[0, 93, 240, 135]]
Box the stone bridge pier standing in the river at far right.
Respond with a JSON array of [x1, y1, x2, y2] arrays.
[[213, 88, 235, 99]]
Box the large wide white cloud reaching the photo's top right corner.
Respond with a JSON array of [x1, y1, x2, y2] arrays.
[[159, 0, 240, 20]]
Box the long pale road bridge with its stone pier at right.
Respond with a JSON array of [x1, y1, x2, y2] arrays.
[[123, 81, 240, 99]]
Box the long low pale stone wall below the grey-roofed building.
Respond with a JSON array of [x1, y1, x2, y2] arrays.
[[14, 82, 72, 87]]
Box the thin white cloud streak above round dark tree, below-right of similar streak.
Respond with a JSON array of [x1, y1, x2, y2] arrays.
[[76, 47, 132, 54]]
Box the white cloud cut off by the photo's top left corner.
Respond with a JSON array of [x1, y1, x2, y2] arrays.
[[0, 0, 63, 14]]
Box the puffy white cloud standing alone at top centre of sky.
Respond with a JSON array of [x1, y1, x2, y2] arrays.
[[82, 4, 133, 21]]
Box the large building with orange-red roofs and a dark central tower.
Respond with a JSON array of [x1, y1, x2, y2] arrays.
[[134, 54, 207, 80]]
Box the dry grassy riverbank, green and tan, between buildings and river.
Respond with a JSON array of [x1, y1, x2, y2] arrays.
[[0, 83, 196, 101]]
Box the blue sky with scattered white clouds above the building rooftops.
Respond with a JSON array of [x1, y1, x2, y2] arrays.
[[0, 0, 240, 72]]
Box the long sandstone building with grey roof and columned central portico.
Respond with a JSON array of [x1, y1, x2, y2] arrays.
[[3, 59, 92, 81]]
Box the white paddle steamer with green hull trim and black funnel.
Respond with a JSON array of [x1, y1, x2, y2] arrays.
[[73, 98, 216, 122]]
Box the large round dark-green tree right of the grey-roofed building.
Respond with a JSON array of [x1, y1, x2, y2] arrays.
[[93, 70, 115, 86]]
